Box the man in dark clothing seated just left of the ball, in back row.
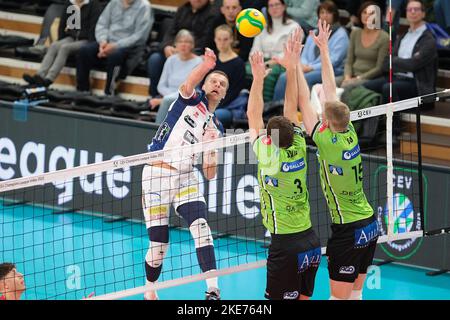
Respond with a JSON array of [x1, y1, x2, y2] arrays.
[[213, 0, 253, 61]]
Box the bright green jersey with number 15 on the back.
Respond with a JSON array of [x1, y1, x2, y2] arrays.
[[312, 122, 373, 224]]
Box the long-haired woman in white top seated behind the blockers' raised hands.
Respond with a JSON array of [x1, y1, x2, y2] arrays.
[[246, 0, 299, 102]]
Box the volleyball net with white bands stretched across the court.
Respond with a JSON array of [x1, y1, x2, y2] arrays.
[[0, 92, 448, 299]]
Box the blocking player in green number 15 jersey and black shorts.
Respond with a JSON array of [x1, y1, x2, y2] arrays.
[[297, 21, 379, 300]]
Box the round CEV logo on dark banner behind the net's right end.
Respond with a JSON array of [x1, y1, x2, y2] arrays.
[[372, 166, 428, 259]]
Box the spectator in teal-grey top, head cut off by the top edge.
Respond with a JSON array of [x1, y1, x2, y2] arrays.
[[285, 0, 320, 34]]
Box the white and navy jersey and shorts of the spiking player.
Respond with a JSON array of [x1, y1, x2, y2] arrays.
[[142, 91, 224, 228]]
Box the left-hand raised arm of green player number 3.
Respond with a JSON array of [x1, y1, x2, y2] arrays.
[[247, 51, 270, 142]]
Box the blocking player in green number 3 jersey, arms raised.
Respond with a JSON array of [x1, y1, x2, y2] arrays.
[[247, 28, 321, 300]]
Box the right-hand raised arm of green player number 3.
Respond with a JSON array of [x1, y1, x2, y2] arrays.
[[273, 27, 303, 126]]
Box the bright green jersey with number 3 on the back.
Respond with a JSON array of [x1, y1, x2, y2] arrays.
[[253, 128, 311, 234]]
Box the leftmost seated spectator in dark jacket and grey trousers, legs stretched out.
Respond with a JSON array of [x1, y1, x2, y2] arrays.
[[23, 0, 102, 87]]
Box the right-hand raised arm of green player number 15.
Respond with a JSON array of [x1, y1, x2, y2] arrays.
[[310, 20, 337, 101]]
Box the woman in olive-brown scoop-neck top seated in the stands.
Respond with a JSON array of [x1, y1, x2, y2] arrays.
[[336, 1, 389, 88]]
